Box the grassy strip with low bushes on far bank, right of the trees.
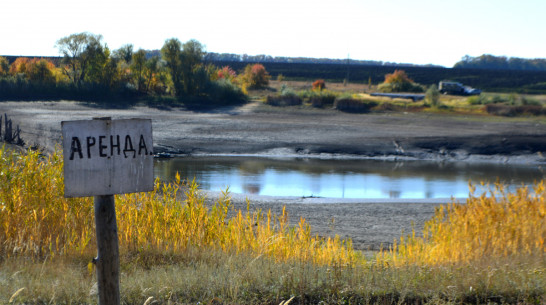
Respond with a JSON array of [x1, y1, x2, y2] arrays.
[[253, 80, 546, 117]]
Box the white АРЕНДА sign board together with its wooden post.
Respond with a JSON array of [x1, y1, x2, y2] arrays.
[[61, 117, 154, 305]]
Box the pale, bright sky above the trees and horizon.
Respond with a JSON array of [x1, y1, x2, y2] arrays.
[[0, 0, 546, 67]]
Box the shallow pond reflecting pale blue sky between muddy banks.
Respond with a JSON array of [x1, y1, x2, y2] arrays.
[[154, 156, 544, 199]]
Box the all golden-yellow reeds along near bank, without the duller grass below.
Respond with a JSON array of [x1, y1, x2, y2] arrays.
[[0, 148, 546, 266]]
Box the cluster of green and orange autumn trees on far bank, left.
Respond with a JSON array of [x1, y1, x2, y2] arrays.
[[0, 32, 269, 104]]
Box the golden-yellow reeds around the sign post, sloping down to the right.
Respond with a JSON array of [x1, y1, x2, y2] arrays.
[[0, 148, 360, 265]]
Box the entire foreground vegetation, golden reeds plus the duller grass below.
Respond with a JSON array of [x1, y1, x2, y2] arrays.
[[0, 149, 546, 304]]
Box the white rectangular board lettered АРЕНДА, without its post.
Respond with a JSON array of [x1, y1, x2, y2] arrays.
[[61, 119, 154, 197]]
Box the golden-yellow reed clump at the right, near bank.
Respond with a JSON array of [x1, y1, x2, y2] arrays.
[[381, 181, 546, 265]]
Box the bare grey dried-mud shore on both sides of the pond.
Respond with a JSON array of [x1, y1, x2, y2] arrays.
[[0, 101, 546, 249]]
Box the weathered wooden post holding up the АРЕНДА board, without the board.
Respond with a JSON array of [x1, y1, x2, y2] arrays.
[[94, 195, 120, 305]]
